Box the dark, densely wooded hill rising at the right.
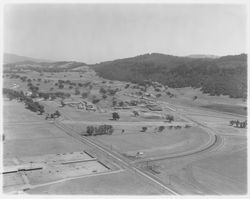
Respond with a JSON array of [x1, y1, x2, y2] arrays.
[[93, 53, 247, 98]]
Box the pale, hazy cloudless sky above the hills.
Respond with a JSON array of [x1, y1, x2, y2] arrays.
[[4, 4, 246, 64]]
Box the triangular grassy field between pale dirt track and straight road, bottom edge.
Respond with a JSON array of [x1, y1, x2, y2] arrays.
[[28, 171, 168, 195]]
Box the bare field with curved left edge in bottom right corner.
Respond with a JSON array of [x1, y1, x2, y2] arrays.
[[190, 145, 247, 194]]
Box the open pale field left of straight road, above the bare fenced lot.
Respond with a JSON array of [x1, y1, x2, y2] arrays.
[[3, 101, 89, 158]]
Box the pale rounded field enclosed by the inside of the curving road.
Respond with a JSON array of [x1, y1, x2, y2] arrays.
[[94, 127, 209, 157]]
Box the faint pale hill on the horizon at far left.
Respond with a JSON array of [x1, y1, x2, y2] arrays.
[[3, 53, 53, 64]]
